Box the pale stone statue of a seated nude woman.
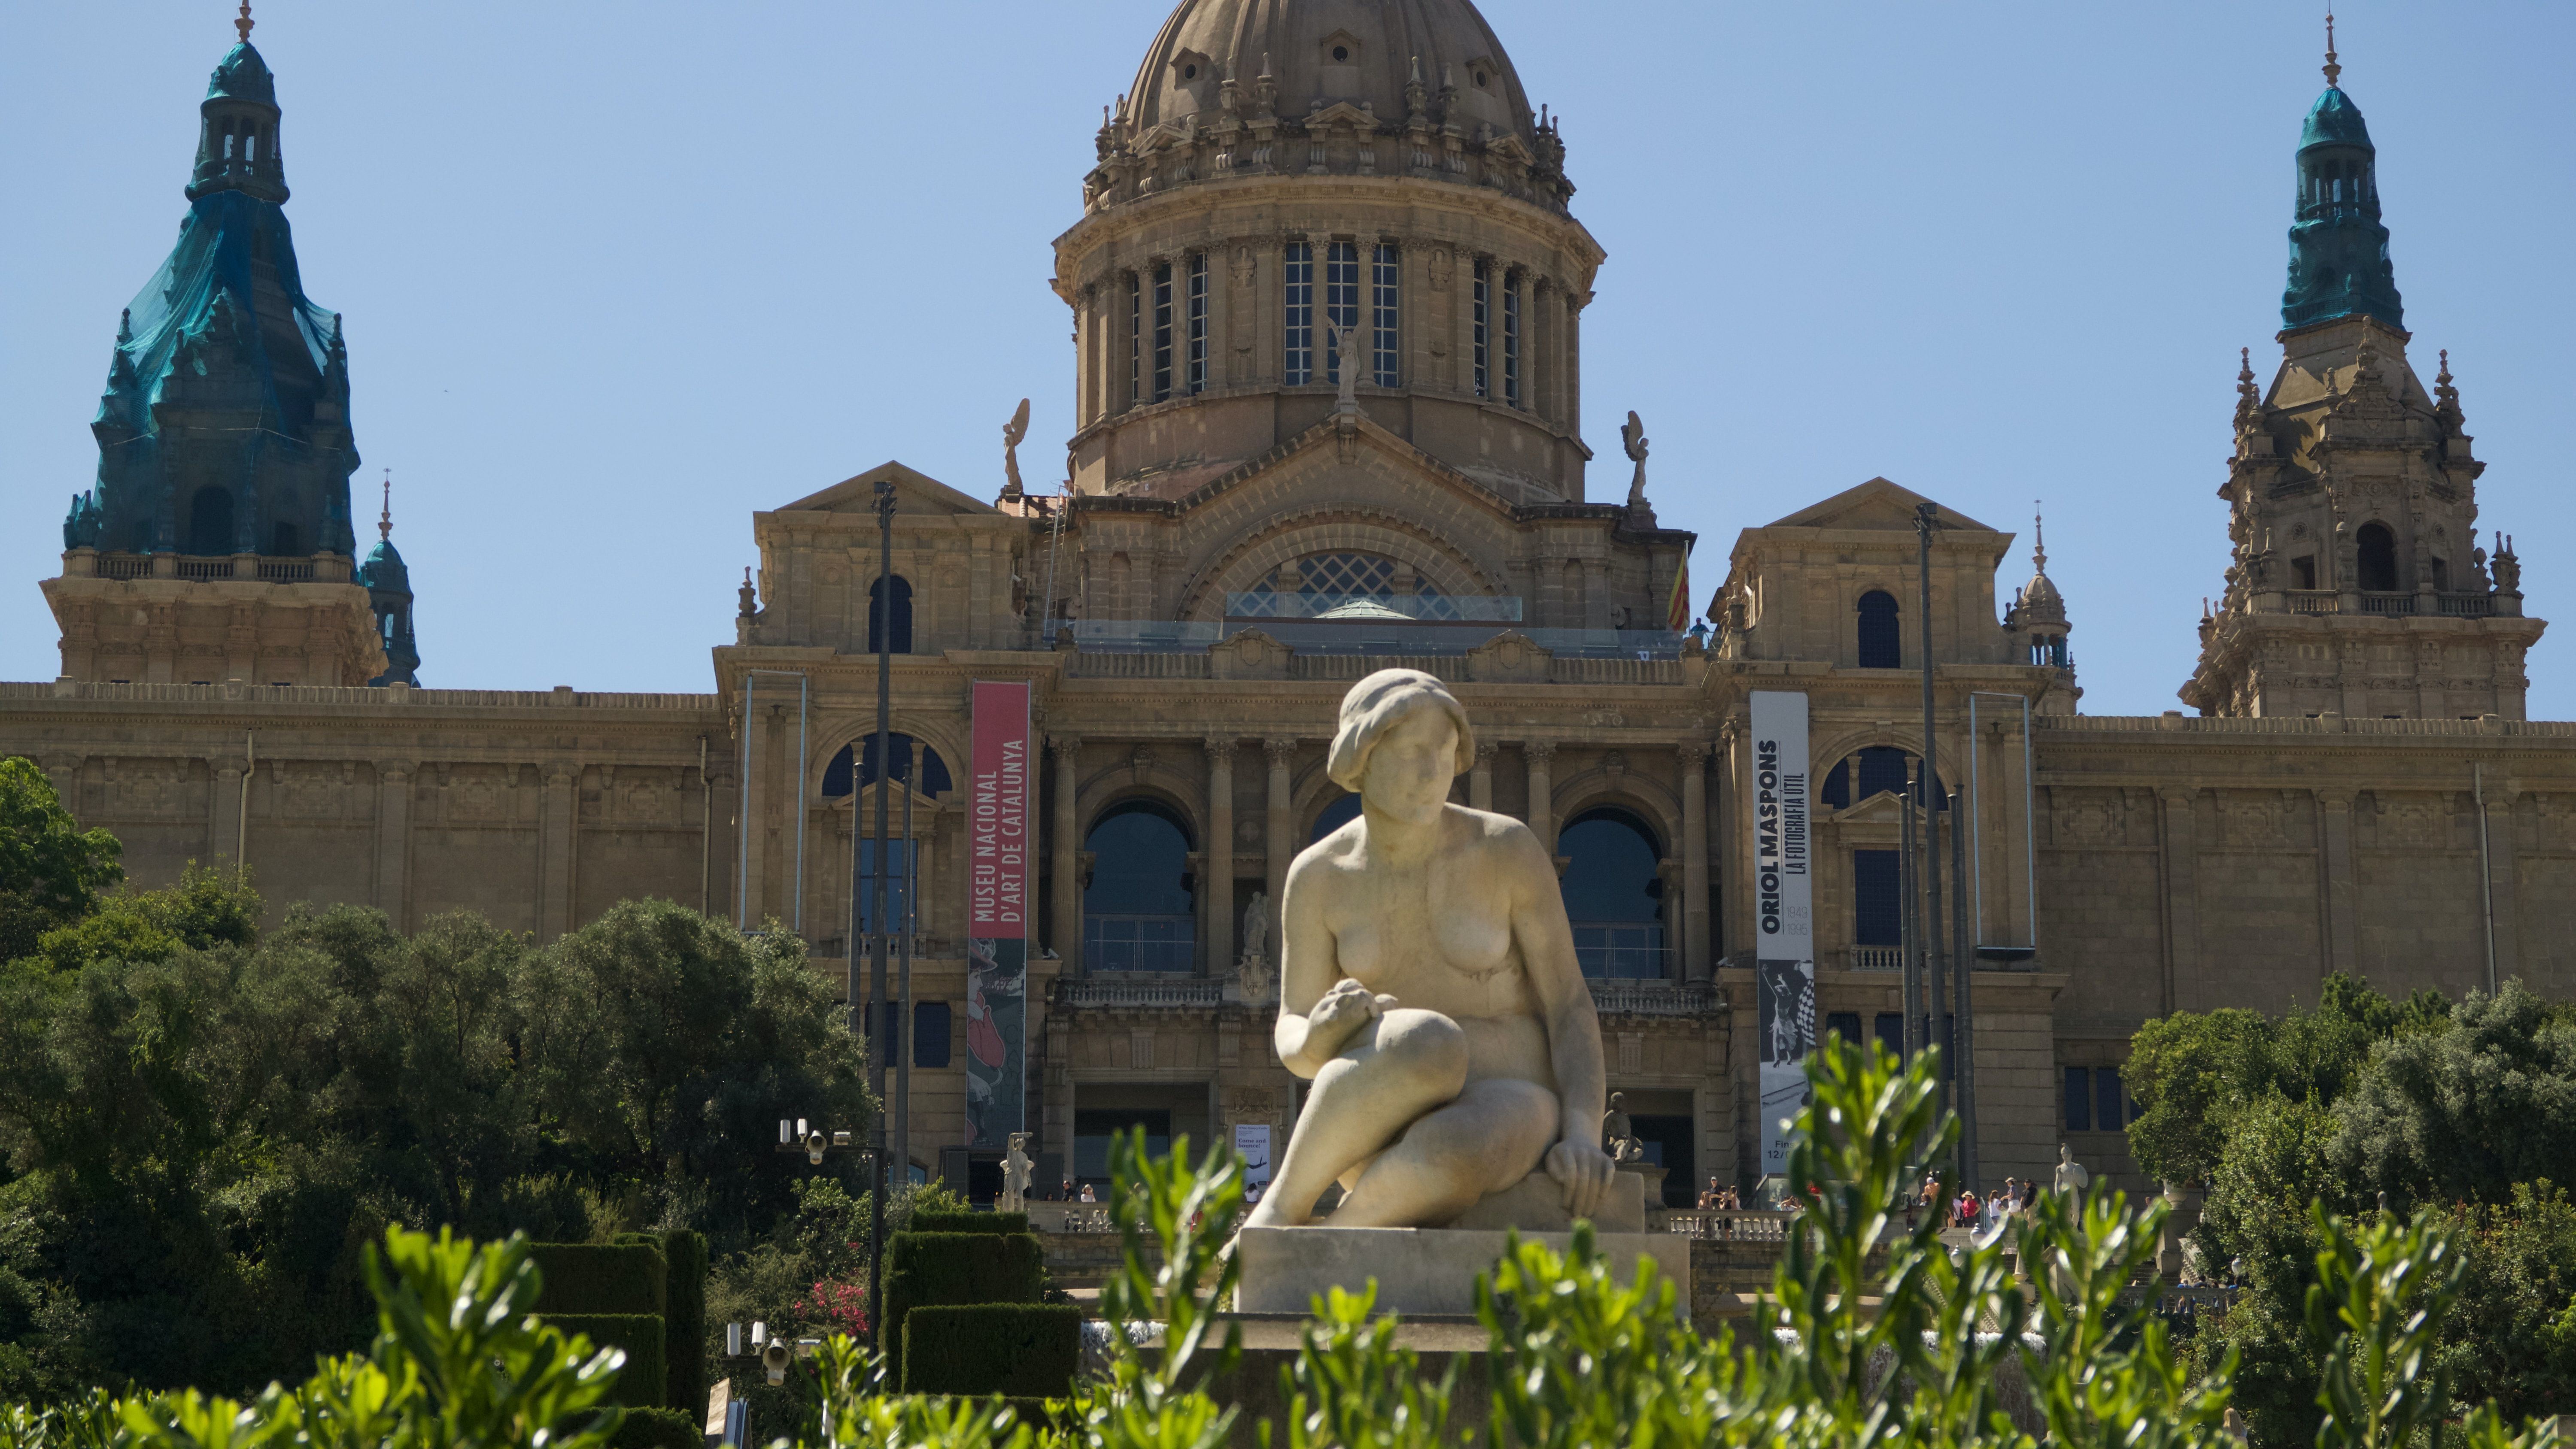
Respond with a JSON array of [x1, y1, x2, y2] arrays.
[[1244, 669, 1615, 1228]]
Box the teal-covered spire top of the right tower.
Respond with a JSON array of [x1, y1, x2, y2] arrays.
[[2280, 18, 2406, 330]]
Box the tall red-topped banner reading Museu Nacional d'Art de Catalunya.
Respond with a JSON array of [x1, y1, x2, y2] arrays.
[[966, 679, 1038, 1150]]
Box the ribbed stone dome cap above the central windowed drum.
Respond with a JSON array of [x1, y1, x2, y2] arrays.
[[1126, 0, 1535, 144]]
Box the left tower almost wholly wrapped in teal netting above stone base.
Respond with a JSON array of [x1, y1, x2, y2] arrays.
[[44, 5, 384, 685]]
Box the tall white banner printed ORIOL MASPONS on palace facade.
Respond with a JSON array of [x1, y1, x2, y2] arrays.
[[1747, 690, 1816, 1176]]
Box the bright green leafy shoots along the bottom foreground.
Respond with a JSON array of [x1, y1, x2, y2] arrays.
[[0, 1045, 2548, 1449]]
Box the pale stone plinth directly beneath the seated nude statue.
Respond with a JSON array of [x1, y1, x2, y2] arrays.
[[1234, 1228, 1690, 1318]]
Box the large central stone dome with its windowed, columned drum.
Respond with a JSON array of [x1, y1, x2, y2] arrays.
[[1056, 0, 1602, 504]]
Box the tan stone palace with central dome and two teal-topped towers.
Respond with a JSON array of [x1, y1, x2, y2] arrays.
[[0, 0, 2576, 1202]]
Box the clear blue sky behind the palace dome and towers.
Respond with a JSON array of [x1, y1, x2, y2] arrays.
[[0, 0, 2576, 718]]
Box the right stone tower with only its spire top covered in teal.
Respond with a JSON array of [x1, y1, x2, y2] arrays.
[[2182, 28, 2545, 721]]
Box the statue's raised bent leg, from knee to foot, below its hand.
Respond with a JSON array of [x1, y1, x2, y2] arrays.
[[1244, 1006, 1468, 1228]]
